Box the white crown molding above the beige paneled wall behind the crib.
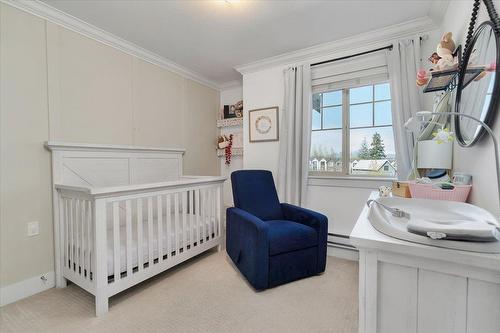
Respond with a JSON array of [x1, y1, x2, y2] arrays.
[[0, 0, 221, 90]]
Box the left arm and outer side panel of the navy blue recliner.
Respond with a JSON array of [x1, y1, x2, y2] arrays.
[[226, 207, 269, 289]]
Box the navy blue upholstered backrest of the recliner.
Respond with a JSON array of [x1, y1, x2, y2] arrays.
[[231, 170, 283, 221]]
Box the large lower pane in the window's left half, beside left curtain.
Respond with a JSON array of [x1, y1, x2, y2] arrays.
[[309, 129, 342, 172]]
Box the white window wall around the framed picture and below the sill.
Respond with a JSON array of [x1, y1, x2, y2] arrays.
[[243, 66, 387, 241]]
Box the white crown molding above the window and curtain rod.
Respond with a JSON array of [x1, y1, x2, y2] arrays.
[[235, 16, 437, 74]]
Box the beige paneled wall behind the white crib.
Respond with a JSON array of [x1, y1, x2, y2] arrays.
[[0, 3, 219, 287]]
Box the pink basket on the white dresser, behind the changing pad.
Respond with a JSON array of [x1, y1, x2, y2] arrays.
[[409, 182, 472, 202]]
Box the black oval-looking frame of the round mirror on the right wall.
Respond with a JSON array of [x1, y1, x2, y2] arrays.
[[454, 21, 500, 147]]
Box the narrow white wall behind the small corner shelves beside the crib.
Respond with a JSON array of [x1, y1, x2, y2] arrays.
[[219, 86, 243, 207]]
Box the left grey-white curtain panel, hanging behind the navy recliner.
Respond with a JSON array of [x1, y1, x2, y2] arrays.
[[278, 65, 312, 205]]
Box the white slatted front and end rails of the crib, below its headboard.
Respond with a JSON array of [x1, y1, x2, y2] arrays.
[[56, 177, 224, 296]]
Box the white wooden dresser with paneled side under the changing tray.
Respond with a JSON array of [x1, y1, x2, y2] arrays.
[[351, 192, 500, 333]]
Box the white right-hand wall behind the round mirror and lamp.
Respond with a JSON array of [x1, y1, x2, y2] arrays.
[[433, 0, 500, 214]]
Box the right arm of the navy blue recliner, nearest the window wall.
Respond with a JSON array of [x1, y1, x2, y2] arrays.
[[281, 203, 328, 273]]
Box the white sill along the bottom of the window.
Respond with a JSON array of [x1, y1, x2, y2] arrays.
[[307, 175, 396, 190]]
